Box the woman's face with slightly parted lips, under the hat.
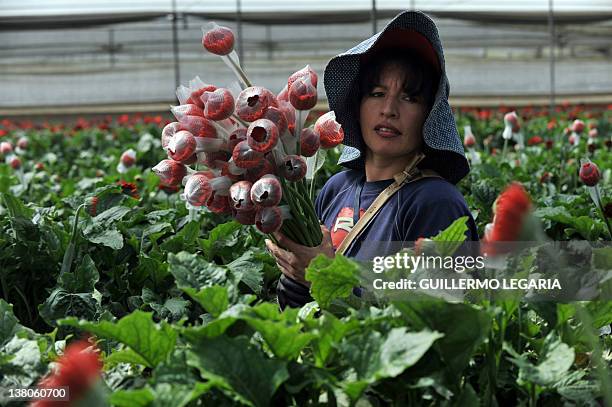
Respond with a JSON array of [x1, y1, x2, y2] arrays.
[[359, 65, 427, 162]]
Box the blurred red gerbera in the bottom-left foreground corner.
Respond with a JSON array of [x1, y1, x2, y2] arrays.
[[32, 339, 102, 407]]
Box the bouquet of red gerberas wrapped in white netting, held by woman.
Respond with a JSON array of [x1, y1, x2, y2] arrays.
[[153, 23, 344, 246]]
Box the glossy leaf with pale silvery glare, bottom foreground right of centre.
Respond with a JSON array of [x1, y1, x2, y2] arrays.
[[340, 327, 444, 401]]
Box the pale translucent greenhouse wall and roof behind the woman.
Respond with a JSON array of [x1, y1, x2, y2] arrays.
[[0, 0, 612, 114]]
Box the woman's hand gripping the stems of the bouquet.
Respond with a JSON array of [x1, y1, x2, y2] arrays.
[[266, 225, 335, 287]]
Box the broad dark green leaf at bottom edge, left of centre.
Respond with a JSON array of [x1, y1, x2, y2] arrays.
[[187, 336, 289, 406]]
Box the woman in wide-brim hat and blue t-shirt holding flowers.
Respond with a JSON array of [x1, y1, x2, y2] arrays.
[[266, 12, 478, 308]]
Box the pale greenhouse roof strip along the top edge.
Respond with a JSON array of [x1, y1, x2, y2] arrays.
[[0, 0, 612, 30]]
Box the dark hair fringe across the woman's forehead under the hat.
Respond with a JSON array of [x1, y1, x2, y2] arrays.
[[358, 49, 437, 112]]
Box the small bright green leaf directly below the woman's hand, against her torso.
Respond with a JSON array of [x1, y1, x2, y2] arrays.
[[306, 254, 359, 309]]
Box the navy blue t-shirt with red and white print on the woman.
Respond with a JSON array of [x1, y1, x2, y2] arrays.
[[315, 170, 478, 260]]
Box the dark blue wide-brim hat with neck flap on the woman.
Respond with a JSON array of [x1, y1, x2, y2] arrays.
[[324, 11, 470, 184]]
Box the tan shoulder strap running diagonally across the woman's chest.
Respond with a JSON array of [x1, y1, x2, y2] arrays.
[[336, 154, 441, 254]]
